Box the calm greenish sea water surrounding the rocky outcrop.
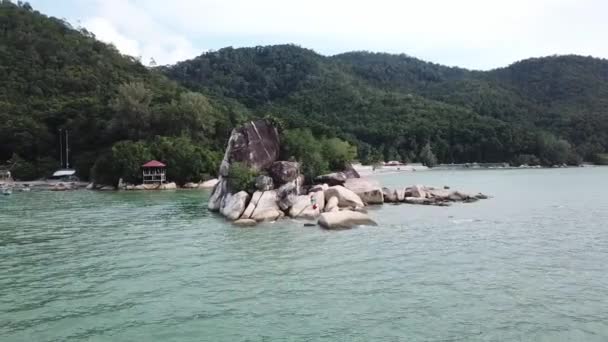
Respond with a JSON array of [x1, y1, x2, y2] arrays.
[[0, 168, 608, 341]]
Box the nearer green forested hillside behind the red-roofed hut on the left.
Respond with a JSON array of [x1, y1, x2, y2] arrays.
[[0, 0, 248, 182]]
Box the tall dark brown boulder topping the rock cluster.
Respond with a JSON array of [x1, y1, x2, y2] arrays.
[[224, 120, 280, 176]]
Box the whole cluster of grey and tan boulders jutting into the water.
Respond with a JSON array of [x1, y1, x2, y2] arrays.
[[208, 120, 485, 229]]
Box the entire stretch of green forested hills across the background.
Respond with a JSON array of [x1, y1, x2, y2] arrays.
[[0, 0, 608, 182]]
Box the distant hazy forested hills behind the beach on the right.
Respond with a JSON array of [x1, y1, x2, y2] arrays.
[[162, 45, 608, 164]]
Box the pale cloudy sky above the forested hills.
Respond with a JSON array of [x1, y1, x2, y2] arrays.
[[29, 0, 608, 70]]
